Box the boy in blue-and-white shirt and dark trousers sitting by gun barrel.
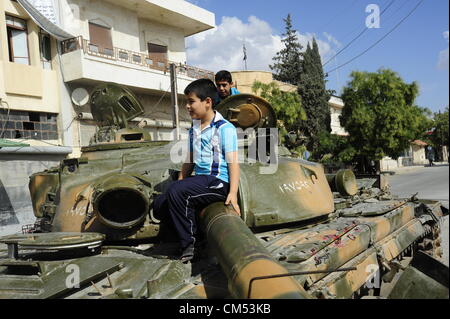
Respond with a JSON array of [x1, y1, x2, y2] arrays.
[[167, 79, 240, 261]]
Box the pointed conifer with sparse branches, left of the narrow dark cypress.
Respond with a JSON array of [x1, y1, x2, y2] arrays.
[[269, 14, 303, 85]]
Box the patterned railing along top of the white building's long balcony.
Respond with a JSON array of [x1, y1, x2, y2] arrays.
[[61, 36, 214, 81]]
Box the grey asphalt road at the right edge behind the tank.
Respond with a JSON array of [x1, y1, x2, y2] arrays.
[[389, 164, 449, 265]]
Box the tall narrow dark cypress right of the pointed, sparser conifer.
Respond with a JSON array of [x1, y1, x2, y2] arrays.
[[298, 39, 331, 158]]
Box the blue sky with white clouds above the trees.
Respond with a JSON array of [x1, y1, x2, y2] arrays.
[[186, 0, 449, 111]]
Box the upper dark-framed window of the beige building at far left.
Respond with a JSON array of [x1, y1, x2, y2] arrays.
[[6, 15, 30, 65]]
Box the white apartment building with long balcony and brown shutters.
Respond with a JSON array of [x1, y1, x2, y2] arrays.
[[58, 0, 215, 156]]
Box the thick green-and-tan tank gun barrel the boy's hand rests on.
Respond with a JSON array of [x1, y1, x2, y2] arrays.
[[200, 203, 310, 299]]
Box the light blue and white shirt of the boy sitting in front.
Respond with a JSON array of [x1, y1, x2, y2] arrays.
[[188, 111, 238, 183]]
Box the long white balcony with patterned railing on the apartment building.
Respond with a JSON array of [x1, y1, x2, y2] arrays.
[[61, 36, 214, 94]]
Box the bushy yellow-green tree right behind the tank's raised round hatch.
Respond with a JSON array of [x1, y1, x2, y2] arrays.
[[252, 81, 306, 157]]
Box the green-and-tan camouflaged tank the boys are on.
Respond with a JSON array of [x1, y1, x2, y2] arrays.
[[0, 83, 448, 299]]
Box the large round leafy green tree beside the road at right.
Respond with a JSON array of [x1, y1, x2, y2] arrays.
[[340, 69, 429, 171]]
